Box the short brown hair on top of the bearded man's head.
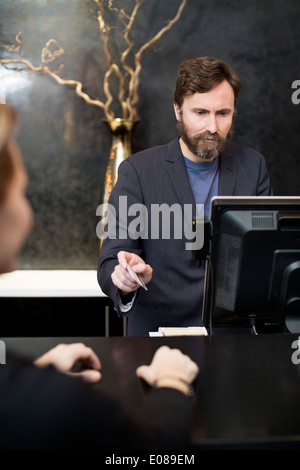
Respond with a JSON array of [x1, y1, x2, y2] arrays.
[[174, 57, 242, 107]]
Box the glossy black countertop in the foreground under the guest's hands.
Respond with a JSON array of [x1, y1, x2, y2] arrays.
[[1, 334, 300, 450]]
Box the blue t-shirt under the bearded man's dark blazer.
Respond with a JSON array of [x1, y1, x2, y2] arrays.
[[184, 157, 219, 217]]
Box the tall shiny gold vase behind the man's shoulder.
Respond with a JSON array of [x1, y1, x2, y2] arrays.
[[100, 118, 138, 248]]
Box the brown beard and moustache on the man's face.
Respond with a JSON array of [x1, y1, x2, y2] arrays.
[[177, 121, 233, 160]]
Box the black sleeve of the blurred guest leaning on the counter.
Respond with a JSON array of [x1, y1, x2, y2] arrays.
[[0, 357, 190, 450]]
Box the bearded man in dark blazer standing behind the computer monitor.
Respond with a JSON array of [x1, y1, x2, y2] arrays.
[[98, 57, 272, 336]]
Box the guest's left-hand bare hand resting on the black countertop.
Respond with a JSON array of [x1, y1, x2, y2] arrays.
[[34, 343, 101, 383]]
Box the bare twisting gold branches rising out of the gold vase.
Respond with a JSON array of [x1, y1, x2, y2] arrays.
[[0, 0, 187, 120]]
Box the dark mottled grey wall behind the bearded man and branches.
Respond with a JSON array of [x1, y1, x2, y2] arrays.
[[0, 0, 300, 269]]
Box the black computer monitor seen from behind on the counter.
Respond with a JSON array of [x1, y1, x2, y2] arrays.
[[202, 196, 300, 333]]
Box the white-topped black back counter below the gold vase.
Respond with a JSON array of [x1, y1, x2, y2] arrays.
[[0, 269, 126, 336]]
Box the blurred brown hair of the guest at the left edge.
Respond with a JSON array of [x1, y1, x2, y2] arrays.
[[0, 104, 17, 204]]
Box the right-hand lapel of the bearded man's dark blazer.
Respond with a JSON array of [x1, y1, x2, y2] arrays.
[[218, 145, 236, 196]]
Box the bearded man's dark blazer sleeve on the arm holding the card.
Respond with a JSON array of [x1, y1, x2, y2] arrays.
[[97, 159, 143, 316]]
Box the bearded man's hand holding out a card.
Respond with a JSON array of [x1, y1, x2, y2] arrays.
[[111, 251, 153, 295]]
